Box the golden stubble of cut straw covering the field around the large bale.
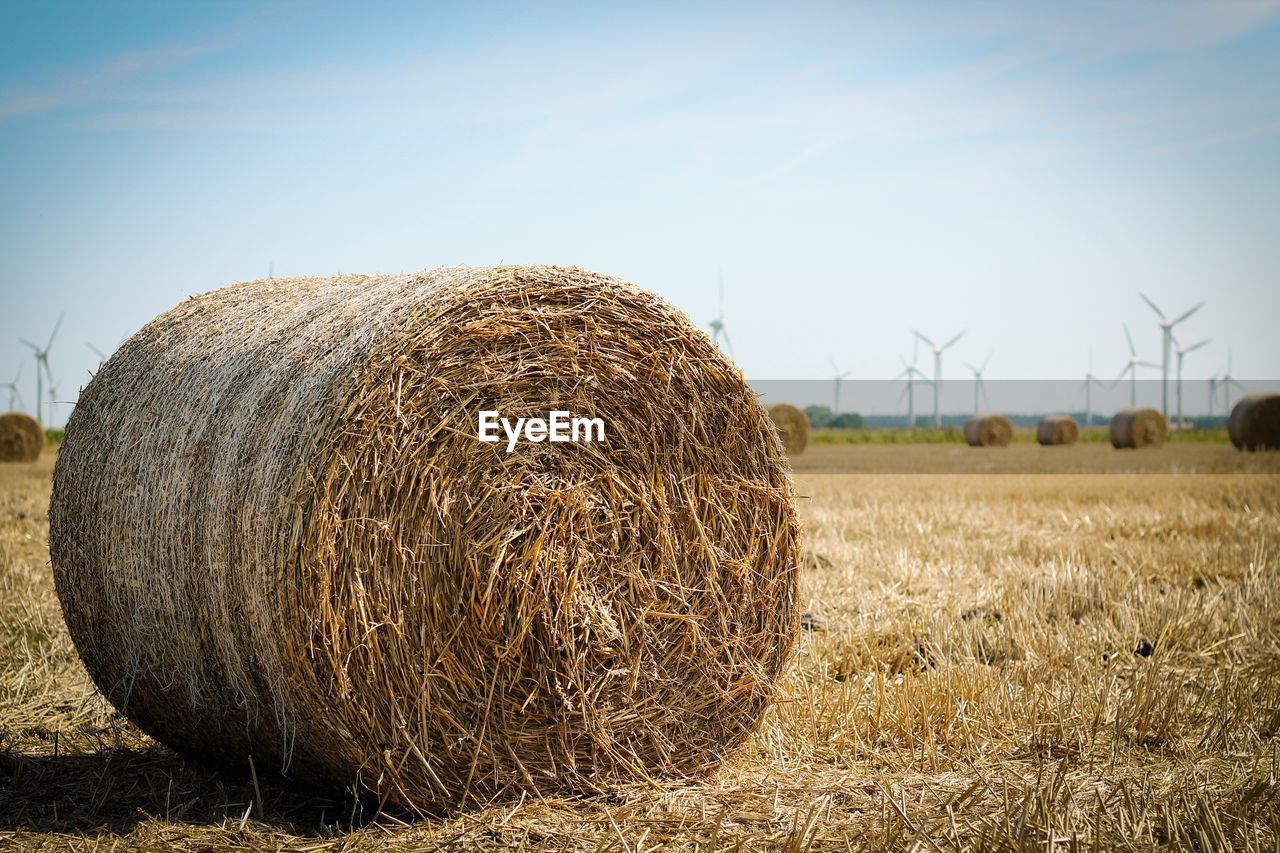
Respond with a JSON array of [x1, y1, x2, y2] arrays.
[[0, 447, 1280, 850]]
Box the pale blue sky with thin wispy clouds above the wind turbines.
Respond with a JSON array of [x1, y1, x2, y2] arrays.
[[0, 0, 1280, 422]]
